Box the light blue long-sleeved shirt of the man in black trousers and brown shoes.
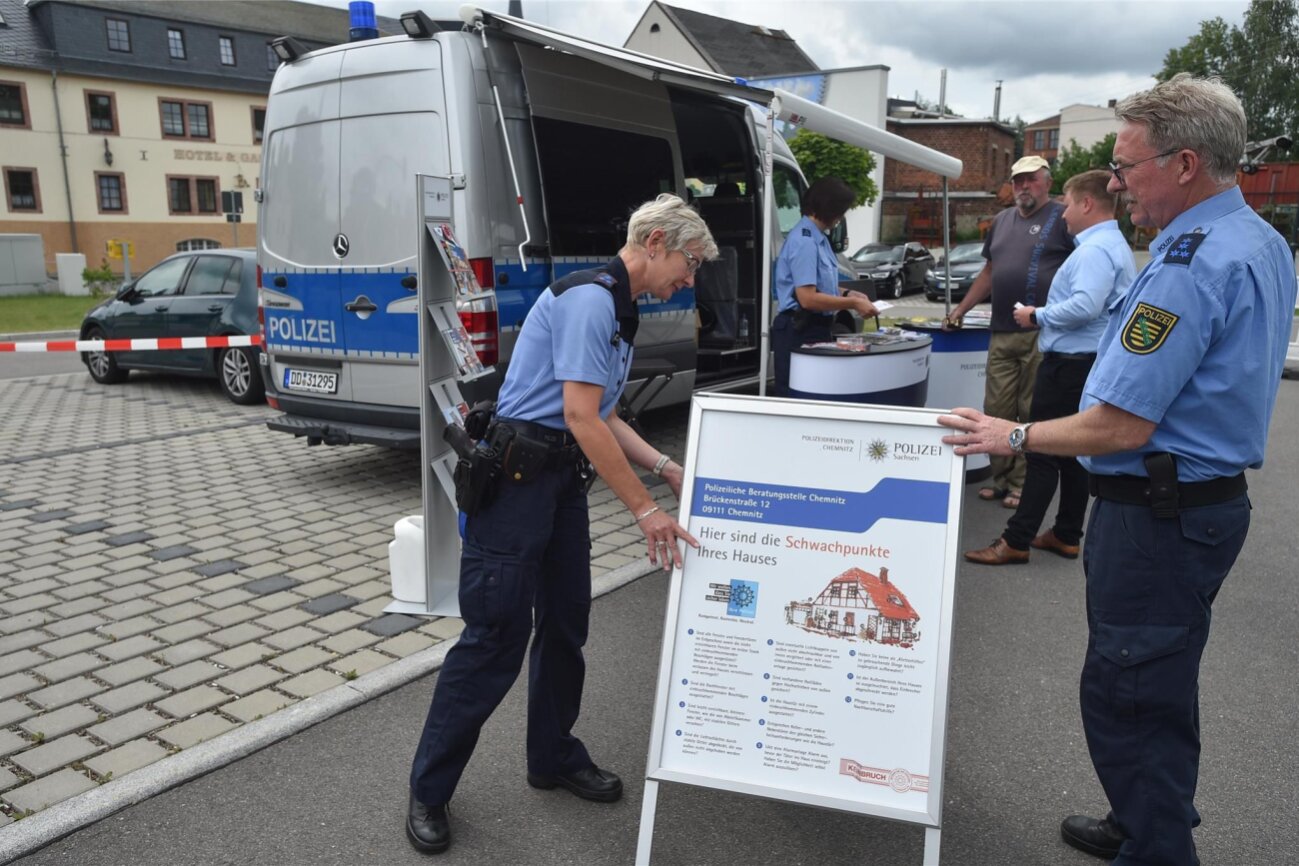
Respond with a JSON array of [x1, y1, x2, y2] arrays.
[[1034, 219, 1137, 354]]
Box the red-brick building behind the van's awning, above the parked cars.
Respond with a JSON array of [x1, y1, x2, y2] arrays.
[[879, 117, 1015, 244]]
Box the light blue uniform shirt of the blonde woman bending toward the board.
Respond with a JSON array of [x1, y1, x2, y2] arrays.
[[496, 268, 633, 430]]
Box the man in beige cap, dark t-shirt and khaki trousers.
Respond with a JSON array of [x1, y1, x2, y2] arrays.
[[943, 156, 1074, 508]]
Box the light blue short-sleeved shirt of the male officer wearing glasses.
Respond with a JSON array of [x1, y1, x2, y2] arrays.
[[1081, 187, 1295, 482]]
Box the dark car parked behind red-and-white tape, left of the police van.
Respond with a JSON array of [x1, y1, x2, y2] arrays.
[[81, 249, 265, 405]]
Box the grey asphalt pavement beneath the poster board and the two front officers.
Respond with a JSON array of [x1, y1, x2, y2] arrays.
[[17, 380, 1299, 866]]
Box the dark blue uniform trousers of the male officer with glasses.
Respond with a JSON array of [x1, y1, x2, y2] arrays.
[[1079, 495, 1250, 866]]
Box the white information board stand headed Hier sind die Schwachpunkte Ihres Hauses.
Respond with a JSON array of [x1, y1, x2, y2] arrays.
[[642, 395, 964, 862]]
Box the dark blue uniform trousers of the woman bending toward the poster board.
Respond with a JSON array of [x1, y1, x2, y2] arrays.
[[410, 465, 591, 805]]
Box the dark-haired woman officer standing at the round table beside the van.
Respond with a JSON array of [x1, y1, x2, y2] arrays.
[[772, 177, 876, 397]]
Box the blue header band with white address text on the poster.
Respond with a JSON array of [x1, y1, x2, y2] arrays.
[[690, 478, 950, 532]]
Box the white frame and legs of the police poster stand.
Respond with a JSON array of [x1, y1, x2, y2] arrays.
[[637, 393, 965, 863]]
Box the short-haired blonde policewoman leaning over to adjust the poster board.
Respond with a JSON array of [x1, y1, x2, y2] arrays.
[[407, 193, 717, 853]]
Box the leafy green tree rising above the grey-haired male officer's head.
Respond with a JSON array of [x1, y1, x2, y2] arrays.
[[1155, 0, 1299, 140]]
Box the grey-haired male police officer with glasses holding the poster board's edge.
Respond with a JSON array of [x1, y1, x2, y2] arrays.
[[939, 74, 1295, 866]]
